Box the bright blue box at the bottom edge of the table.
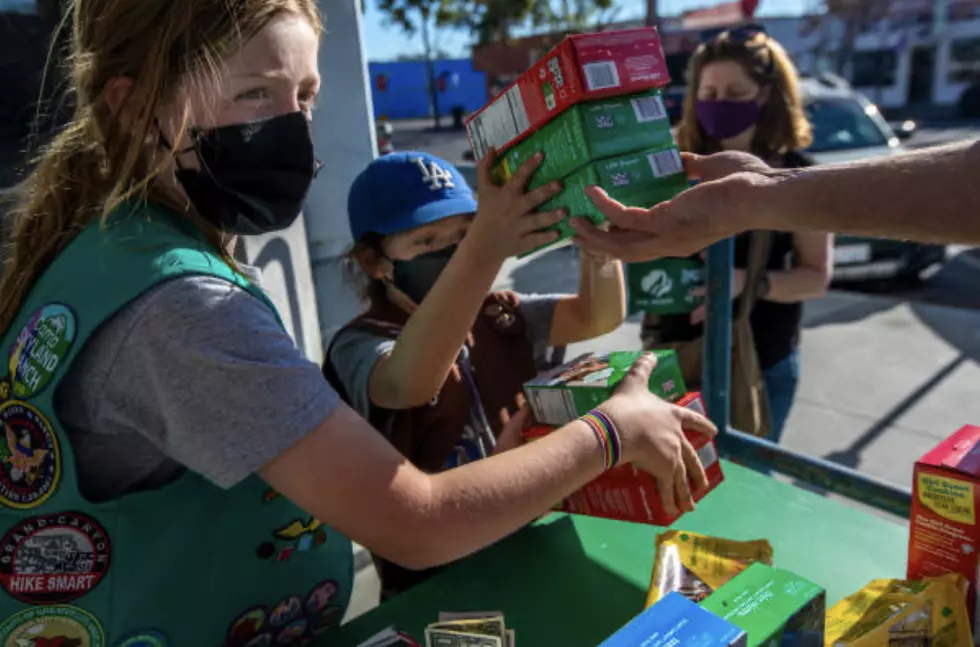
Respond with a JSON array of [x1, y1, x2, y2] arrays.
[[599, 593, 746, 647]]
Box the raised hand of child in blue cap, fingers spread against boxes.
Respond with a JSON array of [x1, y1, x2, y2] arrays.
[[466, 149, 565, 262]]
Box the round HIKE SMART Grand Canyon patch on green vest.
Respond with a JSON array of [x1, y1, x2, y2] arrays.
[[0, 512, 110, 604]]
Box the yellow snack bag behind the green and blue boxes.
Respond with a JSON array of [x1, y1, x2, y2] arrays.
[[644, 530, 772, 608]]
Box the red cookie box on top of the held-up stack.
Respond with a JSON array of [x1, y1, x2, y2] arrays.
[[466, 27, 670, 160]]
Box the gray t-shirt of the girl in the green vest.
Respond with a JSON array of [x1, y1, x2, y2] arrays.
[[55, 267, 339, 501]]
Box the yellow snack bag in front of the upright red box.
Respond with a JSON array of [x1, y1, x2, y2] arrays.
[[824, 573, 973, 647]]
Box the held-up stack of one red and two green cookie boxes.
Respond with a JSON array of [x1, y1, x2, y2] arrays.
[[466, 28, 687, 256]]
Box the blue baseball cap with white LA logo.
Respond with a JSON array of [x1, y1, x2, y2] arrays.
[[347, 151, 476, 242]]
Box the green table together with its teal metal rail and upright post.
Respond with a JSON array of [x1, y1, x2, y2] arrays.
[[324, 240, 912, 647]]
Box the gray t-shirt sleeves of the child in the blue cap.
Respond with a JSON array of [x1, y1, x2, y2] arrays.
[[329, 294, 565, 426]]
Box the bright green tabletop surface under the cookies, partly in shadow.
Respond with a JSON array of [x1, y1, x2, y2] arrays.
[[326, 463, 908, 647]]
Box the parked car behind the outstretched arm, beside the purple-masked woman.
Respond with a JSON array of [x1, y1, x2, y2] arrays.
[[802, 75, 946, 282]]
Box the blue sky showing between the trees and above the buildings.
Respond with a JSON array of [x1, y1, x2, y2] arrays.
[[364, 0, 813, 61]]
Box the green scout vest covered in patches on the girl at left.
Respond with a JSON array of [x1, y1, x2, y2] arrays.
[[0, 206, 353, 647]]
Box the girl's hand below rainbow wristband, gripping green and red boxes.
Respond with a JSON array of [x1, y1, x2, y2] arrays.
[[601, 353, 718, 515]]
